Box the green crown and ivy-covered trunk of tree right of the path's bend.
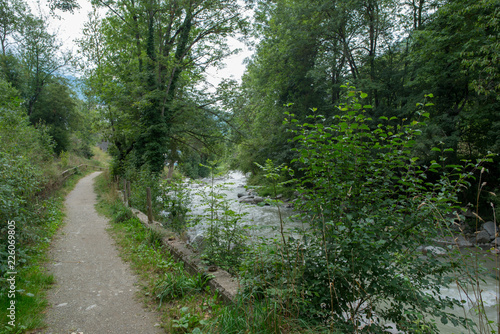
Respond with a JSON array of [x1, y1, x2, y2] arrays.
[[80, 0, 250, 174]]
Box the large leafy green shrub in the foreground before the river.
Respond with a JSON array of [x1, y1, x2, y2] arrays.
[[238, 87, 488, 332]]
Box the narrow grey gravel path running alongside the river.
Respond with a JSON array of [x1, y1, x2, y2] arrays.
[[43, 173, 164, 334]]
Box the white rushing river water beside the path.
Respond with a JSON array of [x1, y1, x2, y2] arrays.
[[187, 172, 499, 334]]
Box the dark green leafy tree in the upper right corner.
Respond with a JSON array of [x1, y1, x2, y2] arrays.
[[409, 0, 500, 159]]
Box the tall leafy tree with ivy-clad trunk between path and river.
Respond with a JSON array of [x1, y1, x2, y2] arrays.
[[82, 0, 250, 173]]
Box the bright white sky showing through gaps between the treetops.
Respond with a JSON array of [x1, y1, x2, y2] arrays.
[[28, 0, 252, 86]]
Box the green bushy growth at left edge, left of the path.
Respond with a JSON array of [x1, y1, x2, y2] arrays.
[[0, 80, 57, 270]]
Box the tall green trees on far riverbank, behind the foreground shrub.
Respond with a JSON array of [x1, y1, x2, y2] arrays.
[[232, 0, 500, 220]]
